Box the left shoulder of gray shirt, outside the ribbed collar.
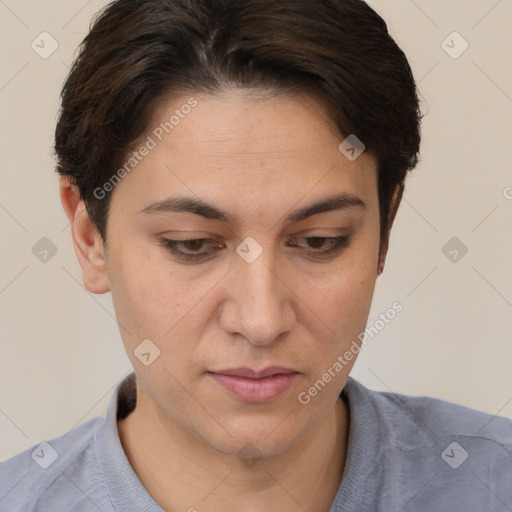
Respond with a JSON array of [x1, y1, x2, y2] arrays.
[[0, 417, 109, 512]]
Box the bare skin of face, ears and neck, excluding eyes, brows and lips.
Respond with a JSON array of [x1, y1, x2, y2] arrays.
[[60, 90, 403, 512]]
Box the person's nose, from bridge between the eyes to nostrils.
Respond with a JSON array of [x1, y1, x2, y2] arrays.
[[220, 243, 296, 345]]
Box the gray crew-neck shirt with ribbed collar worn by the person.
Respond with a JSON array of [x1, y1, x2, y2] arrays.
[[0, 373, 512, 512]]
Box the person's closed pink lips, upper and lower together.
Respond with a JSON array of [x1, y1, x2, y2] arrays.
[[208, 366, 299, 403]]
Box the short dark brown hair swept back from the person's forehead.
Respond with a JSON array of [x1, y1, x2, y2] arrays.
[[55, 0, 421, 241]]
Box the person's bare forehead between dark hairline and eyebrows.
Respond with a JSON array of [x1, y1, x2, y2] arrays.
[[109, 91, 376, 224]]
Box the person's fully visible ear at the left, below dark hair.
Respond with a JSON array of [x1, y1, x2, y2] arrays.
[[59, 176, 110, 293]]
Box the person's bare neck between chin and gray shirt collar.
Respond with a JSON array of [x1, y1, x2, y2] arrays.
[[118, 385, 348, 512]]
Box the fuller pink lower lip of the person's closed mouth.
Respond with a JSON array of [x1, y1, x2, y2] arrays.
[[208, 373, 298, 403]]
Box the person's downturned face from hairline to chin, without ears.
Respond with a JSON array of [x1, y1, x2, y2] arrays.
[[102, 91, 379, 456]]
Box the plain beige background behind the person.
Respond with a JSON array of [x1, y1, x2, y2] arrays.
[[0, 0, 512, 459]]
